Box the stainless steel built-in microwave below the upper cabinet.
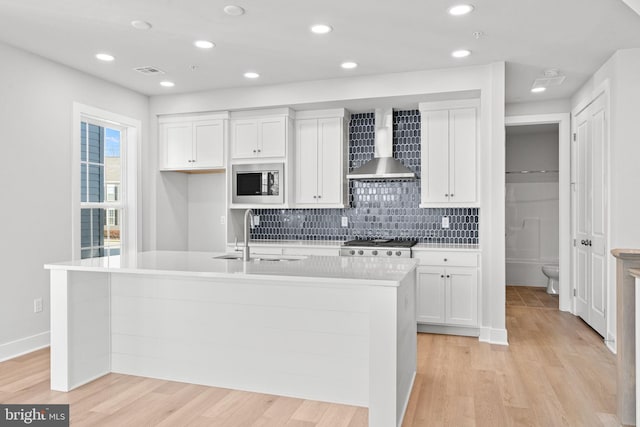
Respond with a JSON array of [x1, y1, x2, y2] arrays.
[[231, 163, 284, 205]]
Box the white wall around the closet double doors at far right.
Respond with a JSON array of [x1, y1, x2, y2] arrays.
[[571, 49, 640, 347]]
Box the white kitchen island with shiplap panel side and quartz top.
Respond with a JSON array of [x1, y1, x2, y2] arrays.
[[45, 251, 416, 427]]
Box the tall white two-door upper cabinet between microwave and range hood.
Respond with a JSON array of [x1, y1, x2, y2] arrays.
[[294, 109, 347, 208]]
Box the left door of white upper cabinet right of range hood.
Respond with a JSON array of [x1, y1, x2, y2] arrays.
[[421, 110, 449, 203]]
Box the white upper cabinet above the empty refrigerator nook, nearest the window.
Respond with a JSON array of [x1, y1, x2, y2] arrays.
[[159, 115, 226, 171]]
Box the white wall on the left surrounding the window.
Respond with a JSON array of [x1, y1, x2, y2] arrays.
[[0, 44, 149, 360]]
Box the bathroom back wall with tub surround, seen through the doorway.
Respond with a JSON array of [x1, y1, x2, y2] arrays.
[[505, 126, 559, 286]]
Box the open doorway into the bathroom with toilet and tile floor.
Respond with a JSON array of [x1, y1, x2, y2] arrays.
[[505, 123, 560, 308]]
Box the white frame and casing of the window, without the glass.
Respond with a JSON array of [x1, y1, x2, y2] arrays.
[[71, 102, 142, 260]]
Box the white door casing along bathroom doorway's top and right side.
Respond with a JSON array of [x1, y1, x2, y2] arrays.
[[504, 113, 575, 314]]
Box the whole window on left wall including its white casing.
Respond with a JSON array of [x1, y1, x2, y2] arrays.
[[71, 102, 142, 259]]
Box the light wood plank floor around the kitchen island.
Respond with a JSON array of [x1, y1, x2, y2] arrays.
[[0, 300, 618, 427]]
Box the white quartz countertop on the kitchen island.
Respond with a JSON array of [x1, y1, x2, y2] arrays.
[[45, 251, 417, 286]]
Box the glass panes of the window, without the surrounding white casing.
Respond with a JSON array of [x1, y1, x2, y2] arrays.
[[80, 119, 124, 258]]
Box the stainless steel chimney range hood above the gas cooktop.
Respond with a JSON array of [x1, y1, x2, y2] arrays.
[[347, 109, 416, 180]]
